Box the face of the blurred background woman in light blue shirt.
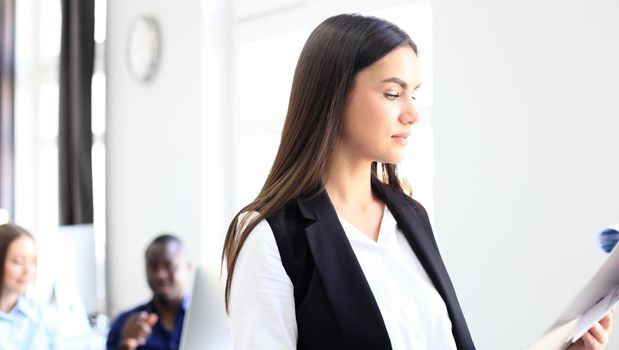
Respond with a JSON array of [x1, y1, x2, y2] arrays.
[[2, 236, 37, 294]]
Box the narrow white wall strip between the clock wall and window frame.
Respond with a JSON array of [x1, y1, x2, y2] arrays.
[[199, 0, 233, 278]]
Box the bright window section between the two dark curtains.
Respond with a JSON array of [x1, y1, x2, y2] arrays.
[[14, 0, 61, 232]]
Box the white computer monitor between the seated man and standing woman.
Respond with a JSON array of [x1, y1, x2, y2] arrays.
[[180, 266, 232, 350]]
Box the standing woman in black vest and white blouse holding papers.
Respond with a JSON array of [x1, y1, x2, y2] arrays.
[[223, 15, 610, 350]]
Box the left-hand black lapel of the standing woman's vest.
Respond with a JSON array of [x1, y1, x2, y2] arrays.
[[297, 190, 391, 349]]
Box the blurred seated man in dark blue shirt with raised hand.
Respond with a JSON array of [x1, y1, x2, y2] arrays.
[[107, 234, 190, 350]]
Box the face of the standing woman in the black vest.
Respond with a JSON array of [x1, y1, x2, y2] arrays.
[[340, 45, 419, 164]]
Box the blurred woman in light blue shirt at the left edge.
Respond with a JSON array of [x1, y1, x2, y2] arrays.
[[0, 224, 56, 350]]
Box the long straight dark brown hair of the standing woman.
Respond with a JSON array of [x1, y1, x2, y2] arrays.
[[222, 14, 417, 309]]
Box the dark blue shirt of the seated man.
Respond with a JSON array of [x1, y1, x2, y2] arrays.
[[107, 297, 189, 350]]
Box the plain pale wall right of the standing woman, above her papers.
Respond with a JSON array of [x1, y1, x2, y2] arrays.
[[434, 0, 619, 349]]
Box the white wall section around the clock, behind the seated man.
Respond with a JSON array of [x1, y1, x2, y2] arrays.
[[106, 0, 202, 314]]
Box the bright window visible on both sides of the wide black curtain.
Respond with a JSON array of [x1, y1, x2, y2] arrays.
[[14, 0, 107, 308]]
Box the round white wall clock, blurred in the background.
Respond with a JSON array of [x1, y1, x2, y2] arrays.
[[127, 17, 160, 81]]
